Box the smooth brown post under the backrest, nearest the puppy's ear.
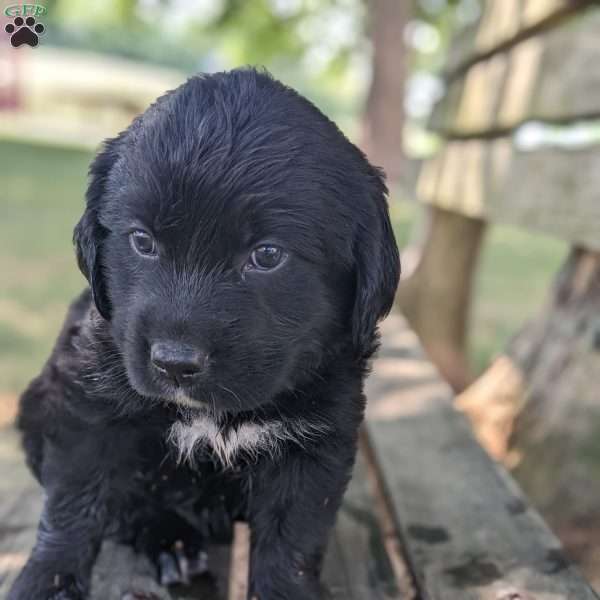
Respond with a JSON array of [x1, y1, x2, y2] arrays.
[[397, 207, 485, 391]]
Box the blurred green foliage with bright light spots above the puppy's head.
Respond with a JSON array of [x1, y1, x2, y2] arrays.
[[38, 0, 481, 138]]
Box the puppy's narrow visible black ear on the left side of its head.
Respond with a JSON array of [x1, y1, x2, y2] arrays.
[[73, 136, 122, 320]]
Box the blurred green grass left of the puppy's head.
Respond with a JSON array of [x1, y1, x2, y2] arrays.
[[0, 142, 91, 392]]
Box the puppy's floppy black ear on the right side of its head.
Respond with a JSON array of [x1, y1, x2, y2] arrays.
[[352, 167, 400, 357]]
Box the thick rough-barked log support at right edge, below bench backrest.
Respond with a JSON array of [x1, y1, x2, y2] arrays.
[[458, 248, 600, 585]]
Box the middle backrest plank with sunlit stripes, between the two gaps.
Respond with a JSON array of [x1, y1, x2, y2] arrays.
[[429, 8, 600, 138]]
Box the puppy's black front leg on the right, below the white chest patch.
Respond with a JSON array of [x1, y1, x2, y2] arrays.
[[248, 440, 355, 600]]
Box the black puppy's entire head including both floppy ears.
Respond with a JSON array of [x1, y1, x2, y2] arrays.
[[75, 70, 399, 412]]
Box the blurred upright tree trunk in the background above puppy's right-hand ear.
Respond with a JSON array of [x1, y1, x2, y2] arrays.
[[361, 0, 409, 182]]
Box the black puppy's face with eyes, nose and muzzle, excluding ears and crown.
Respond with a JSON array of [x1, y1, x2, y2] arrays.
[[101, 173, 352, 411]]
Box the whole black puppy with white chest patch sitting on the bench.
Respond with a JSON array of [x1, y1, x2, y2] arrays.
[[9, 69, 399, 600]]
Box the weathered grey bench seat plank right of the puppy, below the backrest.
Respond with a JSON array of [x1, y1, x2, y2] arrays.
[[368, 317, 598, 600]]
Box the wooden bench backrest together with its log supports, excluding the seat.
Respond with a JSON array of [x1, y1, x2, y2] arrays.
[[397, 0, 600, 590]]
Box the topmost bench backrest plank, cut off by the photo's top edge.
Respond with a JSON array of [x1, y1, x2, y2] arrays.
[[443, 0, 594, 82]]
